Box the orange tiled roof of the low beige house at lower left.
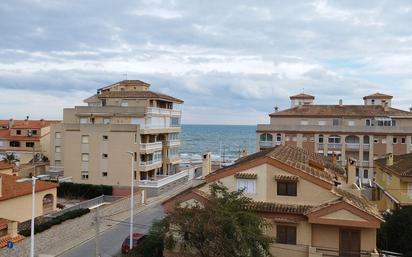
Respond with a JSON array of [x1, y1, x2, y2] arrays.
[[0, 174, 58, 201]]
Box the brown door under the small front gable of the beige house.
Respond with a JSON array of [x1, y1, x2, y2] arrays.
[[339, 229, 360, 257]]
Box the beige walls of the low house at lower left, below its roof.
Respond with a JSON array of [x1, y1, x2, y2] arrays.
[[0, 186, 57, 222]]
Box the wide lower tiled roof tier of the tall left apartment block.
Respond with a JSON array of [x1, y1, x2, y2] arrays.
[[97, 91, 183, 103]]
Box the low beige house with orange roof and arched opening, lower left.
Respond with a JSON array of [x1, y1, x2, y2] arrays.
[[0, 173, 57, 247]]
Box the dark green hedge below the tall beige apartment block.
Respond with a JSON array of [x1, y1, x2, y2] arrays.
[[57, 182, 113, 199]]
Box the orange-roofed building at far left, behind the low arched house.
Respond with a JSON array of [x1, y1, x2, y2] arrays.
[[0, 117, 60, 164]]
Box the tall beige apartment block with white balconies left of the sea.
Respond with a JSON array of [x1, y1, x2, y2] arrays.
[[50, 80, 183, 186]]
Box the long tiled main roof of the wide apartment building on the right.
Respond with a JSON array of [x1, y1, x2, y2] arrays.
[[269, 105, 412, 117]]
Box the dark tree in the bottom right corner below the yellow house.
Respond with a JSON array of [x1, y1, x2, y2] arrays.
[[377, 206, 412, 257]]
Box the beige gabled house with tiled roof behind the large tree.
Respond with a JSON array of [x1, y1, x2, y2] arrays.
[[163, 145, 382, 257]]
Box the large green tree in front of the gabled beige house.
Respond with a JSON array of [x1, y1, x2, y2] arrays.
[[165, 183, 273, 257]]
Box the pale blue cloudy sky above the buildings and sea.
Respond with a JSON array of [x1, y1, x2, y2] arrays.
[[0, 0, 412, 125]]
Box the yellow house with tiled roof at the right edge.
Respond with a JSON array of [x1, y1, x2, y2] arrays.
[[373, 153, 412, 211]]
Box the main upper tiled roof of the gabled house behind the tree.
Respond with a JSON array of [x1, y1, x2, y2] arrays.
[[206, 145, 346, 184]]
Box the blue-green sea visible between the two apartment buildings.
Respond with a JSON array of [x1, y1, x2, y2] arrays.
[[180, 124, 256, 162]]
